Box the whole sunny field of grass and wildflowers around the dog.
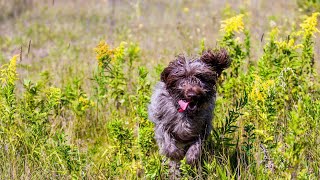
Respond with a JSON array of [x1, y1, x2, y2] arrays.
[[0, 0, 320, 179]]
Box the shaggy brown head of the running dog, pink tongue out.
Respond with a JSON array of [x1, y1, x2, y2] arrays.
[[161, 49, 231, 112]]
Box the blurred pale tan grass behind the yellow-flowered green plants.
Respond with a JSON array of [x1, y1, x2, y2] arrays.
[[0, 0, 319, 88]]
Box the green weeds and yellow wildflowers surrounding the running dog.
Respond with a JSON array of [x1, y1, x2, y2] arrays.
[[0, 2, 320, 179]]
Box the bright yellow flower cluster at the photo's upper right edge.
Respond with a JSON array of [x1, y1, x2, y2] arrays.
[[300, 12, 320, 37]]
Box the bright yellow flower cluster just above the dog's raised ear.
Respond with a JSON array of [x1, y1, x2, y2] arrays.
[[220, 14, 244, 35]]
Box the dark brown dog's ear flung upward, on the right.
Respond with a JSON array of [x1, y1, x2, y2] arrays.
[[200, 49, 231, 76]]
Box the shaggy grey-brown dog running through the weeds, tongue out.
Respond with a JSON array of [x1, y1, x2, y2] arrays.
[[148, 49, 231, 173]]
